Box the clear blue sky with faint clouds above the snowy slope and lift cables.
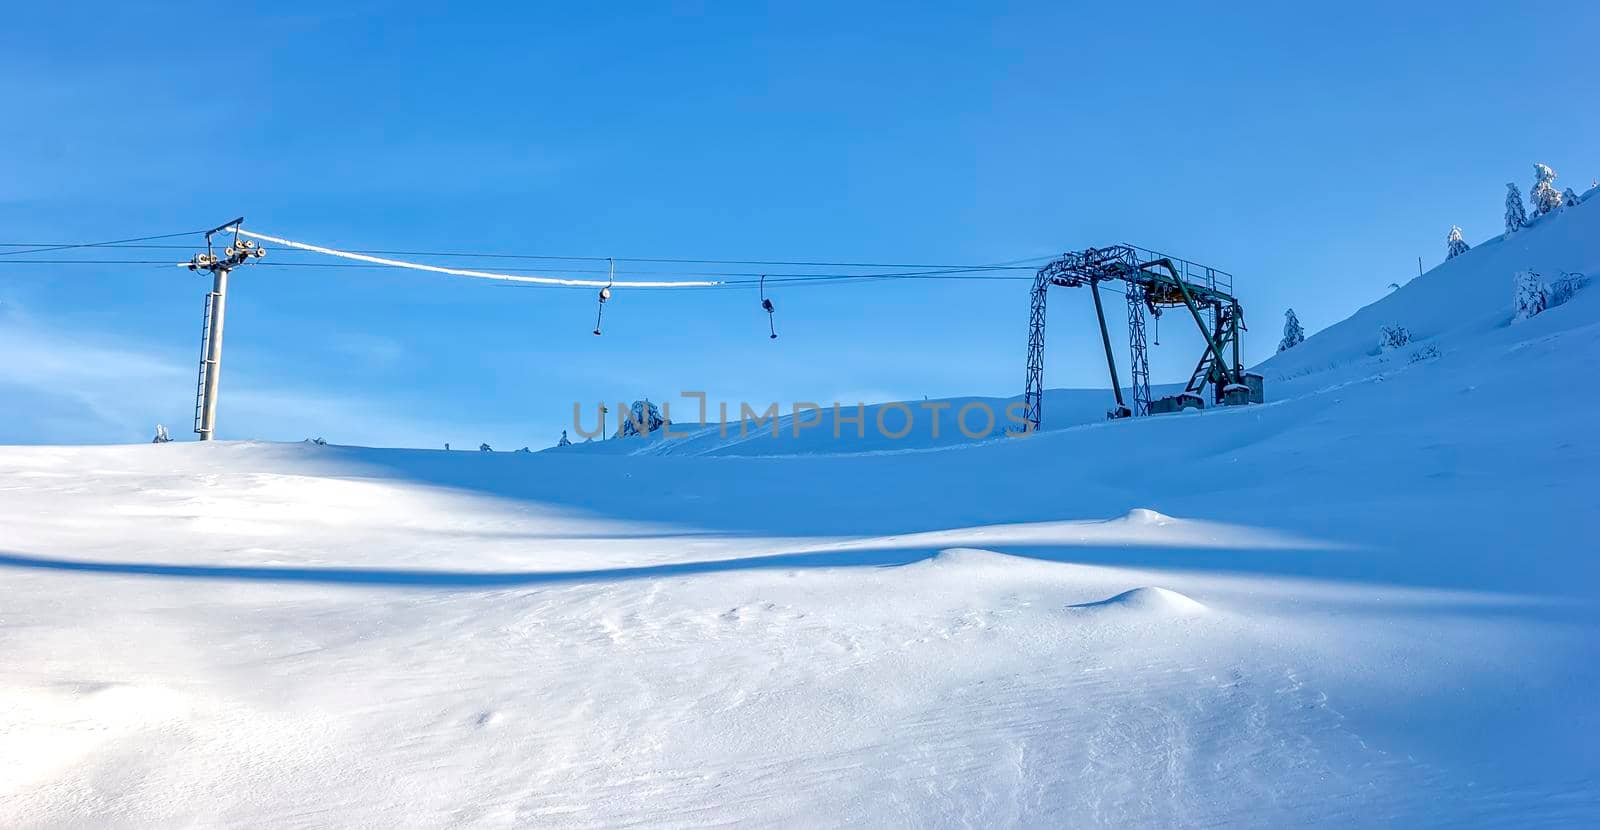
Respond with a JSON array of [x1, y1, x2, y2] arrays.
[[0, 2, 1600, 448]]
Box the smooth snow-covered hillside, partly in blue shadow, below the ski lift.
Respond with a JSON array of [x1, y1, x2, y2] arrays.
[[0, 202, 1600, 827]]
